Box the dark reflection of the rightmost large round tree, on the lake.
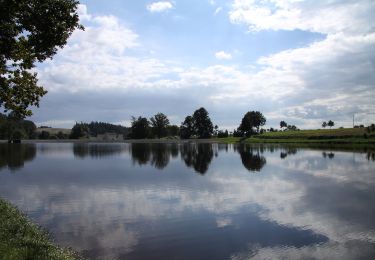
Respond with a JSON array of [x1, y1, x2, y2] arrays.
[[237, 145, 267, 172]]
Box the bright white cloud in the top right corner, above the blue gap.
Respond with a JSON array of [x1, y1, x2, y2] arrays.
[[229, 0, 375, 34]]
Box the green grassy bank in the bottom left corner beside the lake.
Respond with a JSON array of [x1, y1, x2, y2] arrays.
[[0, 198, 77, 260]]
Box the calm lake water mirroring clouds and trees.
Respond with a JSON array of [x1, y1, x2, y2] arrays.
[[0, 143, 375, 259]]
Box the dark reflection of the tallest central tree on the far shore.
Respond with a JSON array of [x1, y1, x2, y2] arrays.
[[181, 143, 214, 174]]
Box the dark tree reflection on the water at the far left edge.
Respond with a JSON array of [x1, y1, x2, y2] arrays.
[[0, 144, 36, 171]]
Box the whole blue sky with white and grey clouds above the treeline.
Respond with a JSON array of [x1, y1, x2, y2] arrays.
[[31, 0, 375, 130]]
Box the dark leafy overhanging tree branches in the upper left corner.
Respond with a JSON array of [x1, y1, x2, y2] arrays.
[[0, 0, 83, 118]]
